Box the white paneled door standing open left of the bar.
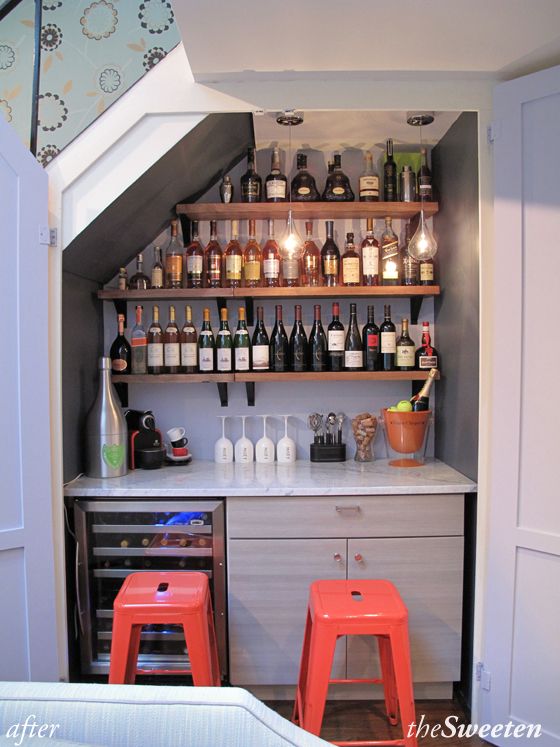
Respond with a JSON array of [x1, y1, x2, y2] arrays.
[[0, 117, 58, 680]]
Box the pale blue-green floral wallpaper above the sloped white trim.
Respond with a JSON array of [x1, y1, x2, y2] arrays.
[[0, 0, 179, 165]]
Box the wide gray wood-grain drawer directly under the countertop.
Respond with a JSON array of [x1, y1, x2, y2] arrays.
[[226, 494, 464, 539]]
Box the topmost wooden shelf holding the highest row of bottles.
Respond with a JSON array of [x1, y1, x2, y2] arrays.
[[176, 202, 438, 220]]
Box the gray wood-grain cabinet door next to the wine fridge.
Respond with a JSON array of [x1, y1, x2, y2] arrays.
[[228, 539, 346, 686]]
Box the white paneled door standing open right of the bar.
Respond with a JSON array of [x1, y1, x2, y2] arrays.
[[478, 67, 560, 747]]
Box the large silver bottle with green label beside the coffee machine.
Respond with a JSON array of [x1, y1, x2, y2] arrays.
[[86, 358, 128, 477]]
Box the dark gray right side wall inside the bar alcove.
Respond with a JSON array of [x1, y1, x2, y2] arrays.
[[432, 112, 480, 480]]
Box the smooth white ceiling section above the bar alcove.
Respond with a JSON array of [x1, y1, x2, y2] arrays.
[[173, 0, 560, 83]]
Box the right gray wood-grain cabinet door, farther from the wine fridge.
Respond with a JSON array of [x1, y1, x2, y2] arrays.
[[348, 537, 463, 682]]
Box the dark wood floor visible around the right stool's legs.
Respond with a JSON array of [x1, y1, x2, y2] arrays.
[[266, 700, 486, 747]]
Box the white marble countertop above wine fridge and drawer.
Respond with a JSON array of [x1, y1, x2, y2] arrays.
[[64, 459, 476, 498]]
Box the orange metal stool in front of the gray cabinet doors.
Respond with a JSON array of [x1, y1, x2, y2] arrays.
[[292, 580, 417, 747]]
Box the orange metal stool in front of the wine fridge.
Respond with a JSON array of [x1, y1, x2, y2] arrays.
[[109, 571, 221, 687]]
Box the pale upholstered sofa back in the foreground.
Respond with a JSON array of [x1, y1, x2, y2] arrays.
[[0, 682, 328, 747]]
